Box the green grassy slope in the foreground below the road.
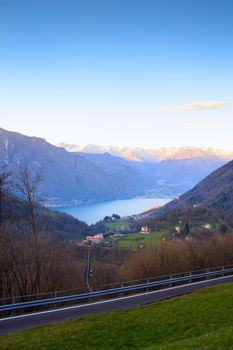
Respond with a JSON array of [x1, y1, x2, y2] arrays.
[[0, 283, 233, 350]]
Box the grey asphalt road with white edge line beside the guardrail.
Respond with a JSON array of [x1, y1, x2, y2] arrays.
[[0, 276, 233, 335]]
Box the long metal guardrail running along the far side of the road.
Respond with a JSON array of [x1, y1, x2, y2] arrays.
[[0, 266, 233, 313]]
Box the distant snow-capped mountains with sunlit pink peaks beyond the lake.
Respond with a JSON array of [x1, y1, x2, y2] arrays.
[[60, 143, 233, 197]]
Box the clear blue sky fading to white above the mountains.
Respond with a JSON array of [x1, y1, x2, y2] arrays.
[[0, 0, 233, 149]]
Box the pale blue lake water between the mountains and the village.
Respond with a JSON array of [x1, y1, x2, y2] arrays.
[[52, 198, 171, 224]]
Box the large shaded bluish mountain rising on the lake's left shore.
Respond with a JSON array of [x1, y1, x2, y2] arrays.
[[0, 129, 160, 205]]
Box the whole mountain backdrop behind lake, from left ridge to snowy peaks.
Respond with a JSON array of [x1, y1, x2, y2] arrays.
[[0, 129, 232, 206]]
